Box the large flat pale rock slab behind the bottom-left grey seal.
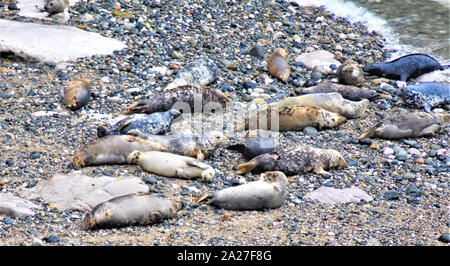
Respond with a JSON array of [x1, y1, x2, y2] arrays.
[[21, 172, 149, 211]]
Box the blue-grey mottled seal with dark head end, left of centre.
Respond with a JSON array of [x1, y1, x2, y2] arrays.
[[97, 109, 181, 138]]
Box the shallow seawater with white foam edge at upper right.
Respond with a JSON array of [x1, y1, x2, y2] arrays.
[[321, 0, 450, 64]]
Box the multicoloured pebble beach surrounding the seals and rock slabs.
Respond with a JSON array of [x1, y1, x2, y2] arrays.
[[0, 0, 450, 246]]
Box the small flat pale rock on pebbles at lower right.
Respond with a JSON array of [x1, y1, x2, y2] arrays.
[[303, 186, 373, 204]]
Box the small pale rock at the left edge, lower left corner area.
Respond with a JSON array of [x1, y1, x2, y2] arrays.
[[0, 193, 42, 217]]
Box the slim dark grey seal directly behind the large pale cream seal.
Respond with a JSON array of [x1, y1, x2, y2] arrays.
[[295, 82, 390, 101]]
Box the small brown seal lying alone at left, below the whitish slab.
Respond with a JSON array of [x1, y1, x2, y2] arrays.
[[64, 79, 91, 111]]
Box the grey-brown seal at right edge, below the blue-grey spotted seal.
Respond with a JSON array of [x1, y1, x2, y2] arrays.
[[359, 112, 450, 139]]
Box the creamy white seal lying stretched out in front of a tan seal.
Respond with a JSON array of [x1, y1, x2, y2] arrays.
[[128, 151, 216, 182]]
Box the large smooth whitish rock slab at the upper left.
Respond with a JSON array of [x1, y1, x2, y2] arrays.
[[0, 19, 126, 63]]
